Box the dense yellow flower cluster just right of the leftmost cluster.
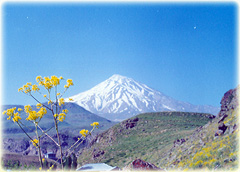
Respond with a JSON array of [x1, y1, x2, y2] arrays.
[[24, 103, 47, 121]]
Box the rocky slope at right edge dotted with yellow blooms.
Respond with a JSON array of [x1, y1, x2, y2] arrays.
[[162, 87, 240, 170]]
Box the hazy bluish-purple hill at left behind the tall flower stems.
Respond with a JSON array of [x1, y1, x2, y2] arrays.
[[2, 103, 116, 155]]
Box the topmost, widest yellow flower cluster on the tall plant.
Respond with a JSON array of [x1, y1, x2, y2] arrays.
[[36, 75, 63, 90]]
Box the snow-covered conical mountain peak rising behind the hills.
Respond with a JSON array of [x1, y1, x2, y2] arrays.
[[67, 75, 219, 120]]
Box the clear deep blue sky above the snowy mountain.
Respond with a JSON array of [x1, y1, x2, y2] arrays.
[[2, 3, 238, 106]]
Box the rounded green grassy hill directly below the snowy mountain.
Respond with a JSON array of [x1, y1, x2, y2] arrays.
[[78, 112, 215, 168]]
